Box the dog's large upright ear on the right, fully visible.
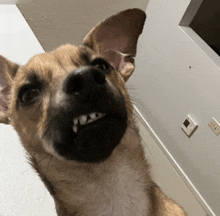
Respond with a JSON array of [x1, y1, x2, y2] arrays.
[[83, 9, 146, 81]]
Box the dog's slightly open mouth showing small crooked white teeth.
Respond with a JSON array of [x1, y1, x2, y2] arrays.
[[73, 112, 106, 134]]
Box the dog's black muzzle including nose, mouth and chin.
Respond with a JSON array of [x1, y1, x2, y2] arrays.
[[45, 66, 127, 163]]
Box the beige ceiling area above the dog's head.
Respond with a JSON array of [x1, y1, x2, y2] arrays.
[[0, 0, 149, 51]]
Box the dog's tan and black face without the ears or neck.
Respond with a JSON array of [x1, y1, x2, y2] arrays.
[[10, 45, 130, 162]]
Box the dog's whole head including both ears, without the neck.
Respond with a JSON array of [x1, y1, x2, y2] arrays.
[[0, 9, 145, 163]]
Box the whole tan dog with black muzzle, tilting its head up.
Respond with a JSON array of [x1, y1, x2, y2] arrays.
[[0, 9, 186, 216]]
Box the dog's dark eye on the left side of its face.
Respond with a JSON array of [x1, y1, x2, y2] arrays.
[[18, 85, 40, 104]]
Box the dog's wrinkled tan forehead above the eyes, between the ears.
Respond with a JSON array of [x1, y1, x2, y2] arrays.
[[17, 44, 96, 82]]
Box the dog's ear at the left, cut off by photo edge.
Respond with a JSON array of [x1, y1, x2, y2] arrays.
[[0, 55, 19, 124]]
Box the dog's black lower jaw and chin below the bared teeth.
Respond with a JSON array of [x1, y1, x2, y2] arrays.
[[53, 115, 127, 163]]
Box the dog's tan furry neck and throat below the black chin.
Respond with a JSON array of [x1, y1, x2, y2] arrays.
[[33, 121, 151, 216]]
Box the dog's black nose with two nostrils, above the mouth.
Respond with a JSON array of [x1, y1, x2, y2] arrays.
[[63, 67, 106, 94]]
